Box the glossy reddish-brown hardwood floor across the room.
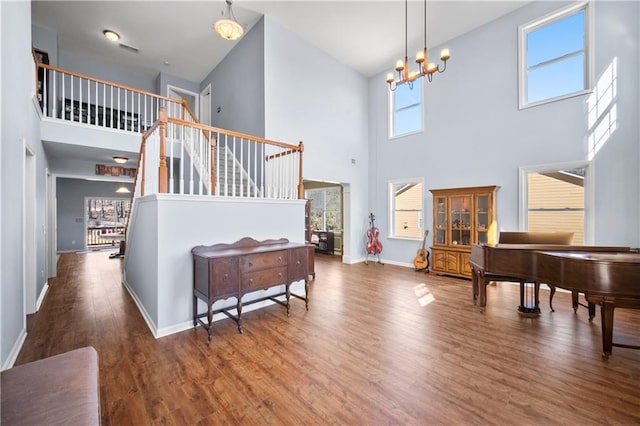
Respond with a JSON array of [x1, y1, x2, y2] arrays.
[[16, 253, 640, 425]]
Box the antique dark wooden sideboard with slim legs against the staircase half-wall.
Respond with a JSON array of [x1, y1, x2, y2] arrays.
[[191, 237, 313, 342]]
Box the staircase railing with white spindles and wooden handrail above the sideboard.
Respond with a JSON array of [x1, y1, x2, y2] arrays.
[[134, 108, 303, 199]]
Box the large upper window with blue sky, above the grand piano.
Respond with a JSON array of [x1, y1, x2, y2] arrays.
[[519, 3, 590, 108]]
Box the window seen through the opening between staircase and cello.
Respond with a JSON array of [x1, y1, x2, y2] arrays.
[[304, 186, 342, 231]]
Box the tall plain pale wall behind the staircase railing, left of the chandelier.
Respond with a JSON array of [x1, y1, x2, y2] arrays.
[[264, 17, 369, 263]]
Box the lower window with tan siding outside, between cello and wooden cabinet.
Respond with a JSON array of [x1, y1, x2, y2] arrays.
[[389, 179, 424, 239]]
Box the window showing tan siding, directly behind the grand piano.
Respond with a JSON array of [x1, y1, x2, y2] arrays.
[[519, 162, 593, 245]]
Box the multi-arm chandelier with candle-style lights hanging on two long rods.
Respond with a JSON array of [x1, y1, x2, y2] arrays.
[[387, 0, 451, 91]]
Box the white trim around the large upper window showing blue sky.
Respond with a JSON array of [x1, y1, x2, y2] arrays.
[[518, 0, 594, 109]]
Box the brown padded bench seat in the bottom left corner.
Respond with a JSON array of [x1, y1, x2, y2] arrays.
[[0, 346, 100, 425]]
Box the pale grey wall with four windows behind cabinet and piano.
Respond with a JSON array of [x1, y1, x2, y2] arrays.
[[369, 2, 640, 263]]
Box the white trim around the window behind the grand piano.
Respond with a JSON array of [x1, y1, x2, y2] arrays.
[[518, 160, 595, 245]]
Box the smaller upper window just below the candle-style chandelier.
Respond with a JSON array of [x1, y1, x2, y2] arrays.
[[389, 81, 423, 138]]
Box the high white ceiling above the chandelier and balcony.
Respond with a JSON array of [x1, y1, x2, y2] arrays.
[[31, 0, 531, 83]]
